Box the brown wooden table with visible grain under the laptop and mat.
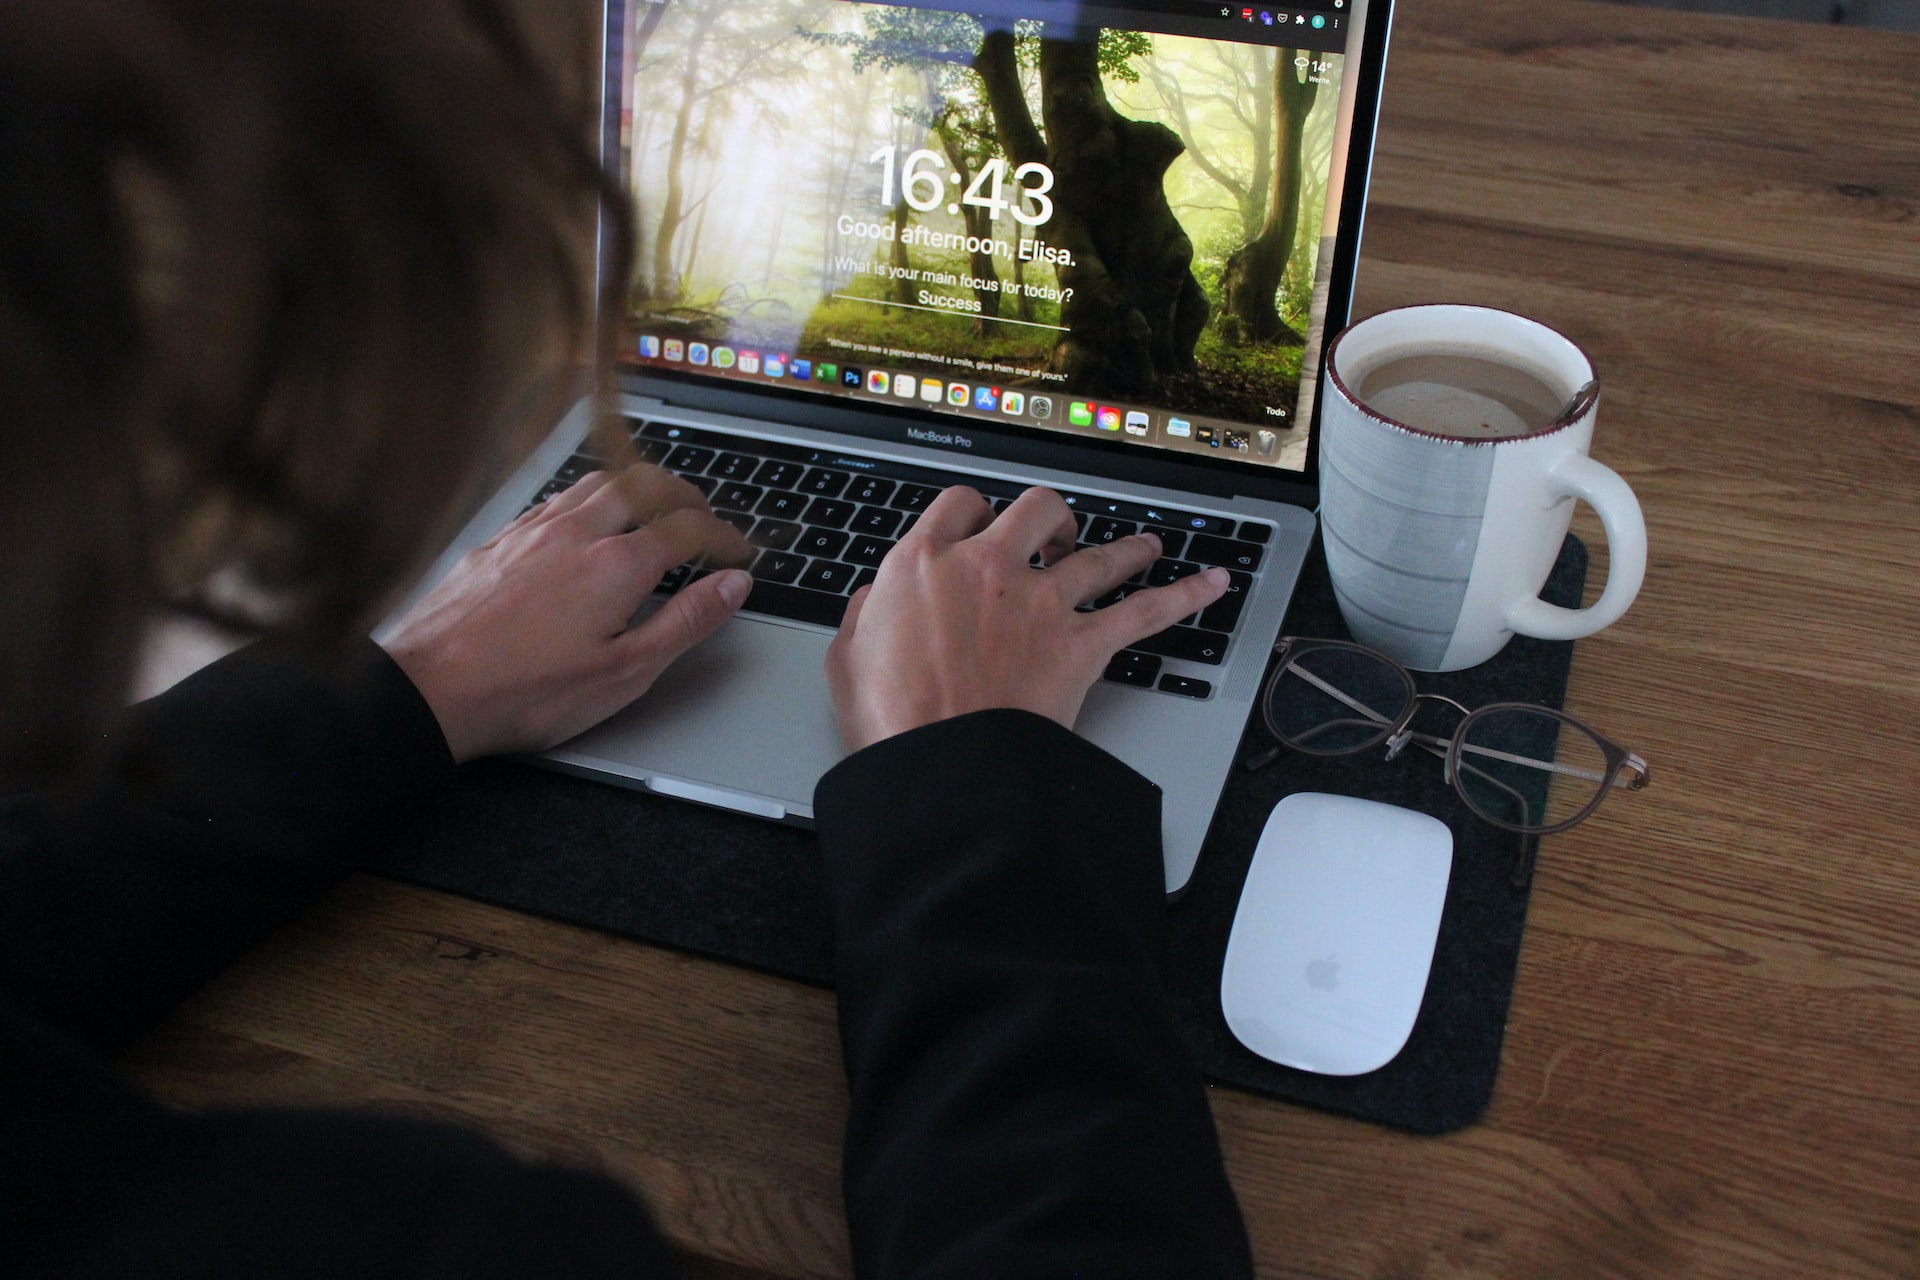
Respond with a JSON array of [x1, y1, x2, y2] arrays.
[[132, 0, 1920, 1278]]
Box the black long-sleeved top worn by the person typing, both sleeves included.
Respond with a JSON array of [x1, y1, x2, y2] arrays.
[[0, 645, 1252, 1280]]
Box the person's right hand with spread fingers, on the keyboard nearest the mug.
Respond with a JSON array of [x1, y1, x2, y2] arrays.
[[828, 487, 1227, 750]]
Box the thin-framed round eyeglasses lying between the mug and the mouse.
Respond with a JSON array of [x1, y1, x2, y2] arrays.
[[1246, 635, 1647, 835]]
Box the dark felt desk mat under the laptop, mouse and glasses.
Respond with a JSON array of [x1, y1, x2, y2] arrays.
[[374, 537, 1586, 1132]]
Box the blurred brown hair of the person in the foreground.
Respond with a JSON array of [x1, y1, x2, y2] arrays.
[[0, 0, 626, 789]]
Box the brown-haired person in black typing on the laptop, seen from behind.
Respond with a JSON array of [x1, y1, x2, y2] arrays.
[[0, 0, 1252, 1280]]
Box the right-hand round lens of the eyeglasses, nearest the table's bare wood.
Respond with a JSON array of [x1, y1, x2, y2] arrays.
[[1457, 706, 1607, 831]]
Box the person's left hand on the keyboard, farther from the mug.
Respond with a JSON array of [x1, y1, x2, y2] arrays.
[[386, 466, 753, 760]]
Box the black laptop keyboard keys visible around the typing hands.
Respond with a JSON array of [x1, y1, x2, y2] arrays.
[[534, 420, 1273, 699]]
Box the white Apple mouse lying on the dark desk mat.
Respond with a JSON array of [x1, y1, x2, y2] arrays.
[[1219, 793, 1453, 1075]]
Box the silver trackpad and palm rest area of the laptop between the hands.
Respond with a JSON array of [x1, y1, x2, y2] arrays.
[[547, 616, 845, 818]]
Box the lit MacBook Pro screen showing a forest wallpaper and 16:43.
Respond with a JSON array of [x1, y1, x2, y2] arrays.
[[609, 0, 1384, 476]]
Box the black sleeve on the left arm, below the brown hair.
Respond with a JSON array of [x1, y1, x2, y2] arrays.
[[0, 643, 453, 1048]]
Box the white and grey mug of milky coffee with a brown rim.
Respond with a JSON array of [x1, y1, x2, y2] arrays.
[[1319, 305, 1647, 672]]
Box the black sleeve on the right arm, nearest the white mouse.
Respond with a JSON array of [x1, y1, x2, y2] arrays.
[[814, 710, 1252, 1280]]
